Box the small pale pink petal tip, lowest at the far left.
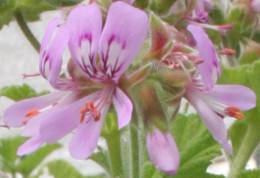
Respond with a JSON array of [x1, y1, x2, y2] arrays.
[[17, 136, 44, 156]]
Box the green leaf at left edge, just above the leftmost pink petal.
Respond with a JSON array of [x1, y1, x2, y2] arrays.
[[0, 84, 47, 101]]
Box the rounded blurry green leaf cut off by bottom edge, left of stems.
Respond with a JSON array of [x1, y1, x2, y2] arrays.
[[47, 160, 104, 178]]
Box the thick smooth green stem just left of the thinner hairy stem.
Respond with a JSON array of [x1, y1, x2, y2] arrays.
[[105, 131, 123, 178]]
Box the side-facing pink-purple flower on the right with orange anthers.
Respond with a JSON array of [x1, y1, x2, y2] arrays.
[[186, 25, 256, 153]]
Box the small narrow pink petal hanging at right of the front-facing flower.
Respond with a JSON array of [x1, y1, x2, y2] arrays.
[[113, 88, 133, 129]]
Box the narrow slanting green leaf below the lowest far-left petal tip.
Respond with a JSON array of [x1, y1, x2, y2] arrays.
[[16, 144, 60, 177]]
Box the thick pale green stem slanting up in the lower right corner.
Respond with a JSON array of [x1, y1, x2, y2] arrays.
[[228, 124, 259, 178]]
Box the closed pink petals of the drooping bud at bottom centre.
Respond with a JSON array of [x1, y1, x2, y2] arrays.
[[146, 129, 180, 175]]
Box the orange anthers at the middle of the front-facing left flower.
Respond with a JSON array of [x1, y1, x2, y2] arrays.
[[80, 101, 100, 123]]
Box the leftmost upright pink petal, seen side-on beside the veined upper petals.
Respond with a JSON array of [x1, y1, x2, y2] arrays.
[[40, 17, 71, 88]]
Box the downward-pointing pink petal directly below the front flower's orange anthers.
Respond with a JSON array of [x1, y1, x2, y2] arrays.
[[69, 102, 109, 159]]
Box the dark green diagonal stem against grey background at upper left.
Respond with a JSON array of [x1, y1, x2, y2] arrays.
[[14, 10, 40, 52]]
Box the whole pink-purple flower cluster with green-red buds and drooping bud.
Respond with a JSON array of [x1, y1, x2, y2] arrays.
[[4, 0, 256, 175]]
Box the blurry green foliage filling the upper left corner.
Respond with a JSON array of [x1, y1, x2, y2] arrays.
[[0, 0, 82, 29]]
